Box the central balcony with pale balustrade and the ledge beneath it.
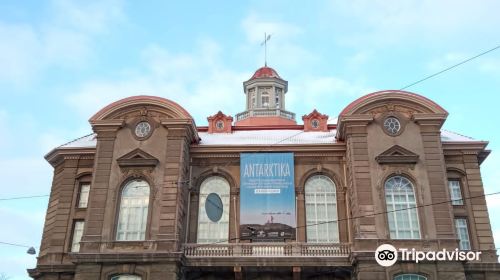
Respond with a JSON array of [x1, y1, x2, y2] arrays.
[[182, 243, 351, 266]]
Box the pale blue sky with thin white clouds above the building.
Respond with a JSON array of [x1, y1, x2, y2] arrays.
[[0, 0, 500, 280]]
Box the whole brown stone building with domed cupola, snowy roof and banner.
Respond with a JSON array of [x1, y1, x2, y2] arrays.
[[28, 67, 500, 280]]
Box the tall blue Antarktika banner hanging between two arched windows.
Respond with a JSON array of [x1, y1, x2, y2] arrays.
[[240, 153, 296, 241]]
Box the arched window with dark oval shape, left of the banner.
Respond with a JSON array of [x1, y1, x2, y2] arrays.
[[198, 176, 229, 243]]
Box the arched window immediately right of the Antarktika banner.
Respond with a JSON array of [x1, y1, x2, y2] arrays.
[[305, 175, 339, 243]]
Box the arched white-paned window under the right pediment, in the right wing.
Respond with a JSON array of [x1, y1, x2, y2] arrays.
[[385, 176, 420, 239]]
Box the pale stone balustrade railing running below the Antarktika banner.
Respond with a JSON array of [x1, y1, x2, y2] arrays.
[[183, 243, 351, 258]]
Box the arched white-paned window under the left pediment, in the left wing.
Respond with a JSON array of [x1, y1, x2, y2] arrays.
[[116, 180, 149, 241]]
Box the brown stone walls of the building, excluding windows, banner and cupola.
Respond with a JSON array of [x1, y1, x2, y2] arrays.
[[28, 91, 500, 280]]
